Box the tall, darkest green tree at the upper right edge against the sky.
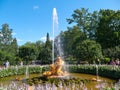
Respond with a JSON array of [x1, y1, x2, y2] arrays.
[[95, 9, 120, 49]]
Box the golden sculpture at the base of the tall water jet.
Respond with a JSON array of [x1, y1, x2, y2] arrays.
[[43, 57, 68, 77]]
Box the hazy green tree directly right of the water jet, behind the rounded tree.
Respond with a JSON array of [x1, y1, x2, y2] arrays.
[[61, 26, 87, 57]]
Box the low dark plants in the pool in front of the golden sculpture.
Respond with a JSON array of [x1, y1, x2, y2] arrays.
[[27, 76, 90, 89]]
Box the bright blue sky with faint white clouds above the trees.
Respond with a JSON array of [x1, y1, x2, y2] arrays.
[[0, 0, 120, 45]]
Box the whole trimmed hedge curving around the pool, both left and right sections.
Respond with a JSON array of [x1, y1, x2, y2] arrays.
[[0, 65, 120, 80]]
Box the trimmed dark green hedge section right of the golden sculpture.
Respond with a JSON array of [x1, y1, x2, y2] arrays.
[[68, 65, 120, 80]]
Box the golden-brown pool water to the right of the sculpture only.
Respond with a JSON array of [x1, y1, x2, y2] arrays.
[[70, 73, 116, 90]]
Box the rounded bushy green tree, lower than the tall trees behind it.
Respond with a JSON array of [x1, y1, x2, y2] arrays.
[[74, 40, 103, 63]]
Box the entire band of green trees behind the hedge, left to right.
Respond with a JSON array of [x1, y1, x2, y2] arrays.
[[0, 8, 120, 65]]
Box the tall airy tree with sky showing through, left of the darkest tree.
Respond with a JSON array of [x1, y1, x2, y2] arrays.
[[67, 8, 99, 39]]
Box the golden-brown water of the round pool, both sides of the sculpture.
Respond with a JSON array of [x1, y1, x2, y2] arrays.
[[0, 73, 116, 90]]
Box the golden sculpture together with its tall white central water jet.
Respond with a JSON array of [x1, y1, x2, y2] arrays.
[[43, 8, 68, 78]]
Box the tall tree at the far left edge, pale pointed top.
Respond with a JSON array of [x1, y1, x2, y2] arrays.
[[0, 23, 18, 64]]
